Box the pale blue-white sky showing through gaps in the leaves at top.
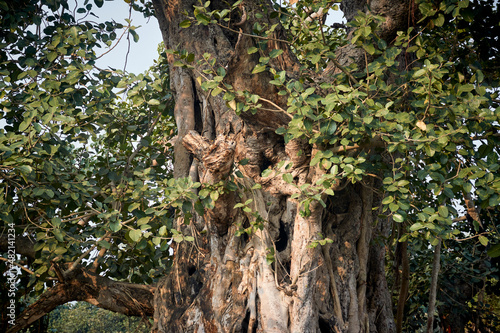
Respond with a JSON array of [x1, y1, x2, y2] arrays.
[[93, 0, 345, 74]]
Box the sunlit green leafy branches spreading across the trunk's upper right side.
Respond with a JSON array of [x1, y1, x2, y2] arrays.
[[180, 1, 500, 245]]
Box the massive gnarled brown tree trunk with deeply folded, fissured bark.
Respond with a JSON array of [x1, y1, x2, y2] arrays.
[[153, 0, 410, 333]]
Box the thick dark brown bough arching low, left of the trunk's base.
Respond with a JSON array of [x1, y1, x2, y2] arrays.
[[7, 266, 156, 333]]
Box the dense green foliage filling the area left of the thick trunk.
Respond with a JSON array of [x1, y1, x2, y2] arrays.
[[0, 1, 176, 298]]
